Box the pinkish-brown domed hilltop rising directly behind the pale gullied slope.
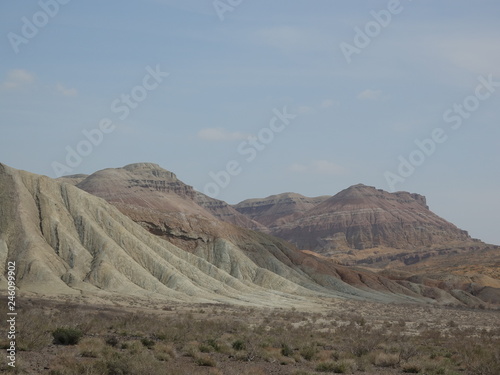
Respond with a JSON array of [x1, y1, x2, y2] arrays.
[[76, 163, 266, 238]]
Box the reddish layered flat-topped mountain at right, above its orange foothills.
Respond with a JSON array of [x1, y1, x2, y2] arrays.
[[236, 184, 471, 254]]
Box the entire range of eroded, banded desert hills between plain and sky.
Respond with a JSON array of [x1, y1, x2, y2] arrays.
[[0, 163, 500, 306]]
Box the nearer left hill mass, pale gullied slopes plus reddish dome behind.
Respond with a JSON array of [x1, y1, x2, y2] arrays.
[[0, 163, 497, 307]]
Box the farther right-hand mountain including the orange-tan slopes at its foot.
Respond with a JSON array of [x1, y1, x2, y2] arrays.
[[235, 185, 500, 303]]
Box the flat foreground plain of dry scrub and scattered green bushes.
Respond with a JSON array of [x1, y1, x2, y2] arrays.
[[0, 301, 500, 375]]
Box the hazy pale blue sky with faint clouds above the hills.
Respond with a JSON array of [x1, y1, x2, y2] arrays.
[[0, 0, 500, 244]]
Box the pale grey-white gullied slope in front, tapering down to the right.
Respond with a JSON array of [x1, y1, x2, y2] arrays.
[[0, 164, 478, 306]]
